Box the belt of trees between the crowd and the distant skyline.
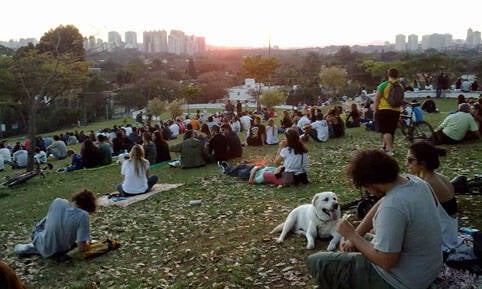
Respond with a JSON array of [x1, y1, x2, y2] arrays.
[[0, 25, 482, 169]]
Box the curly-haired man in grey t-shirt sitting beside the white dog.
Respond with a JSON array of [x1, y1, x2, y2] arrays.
[[308, 150, 442, 289]]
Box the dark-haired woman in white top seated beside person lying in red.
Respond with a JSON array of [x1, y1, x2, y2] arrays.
[[275, 128, 308, 185]]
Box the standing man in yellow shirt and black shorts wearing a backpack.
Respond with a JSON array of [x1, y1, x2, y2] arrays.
[[375, 68, 404, 156]]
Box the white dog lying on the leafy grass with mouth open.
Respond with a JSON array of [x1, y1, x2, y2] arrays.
[[270, 192, 341, 251]]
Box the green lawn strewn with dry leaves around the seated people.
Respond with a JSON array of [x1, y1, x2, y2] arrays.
[[0, 99, 482, 288]]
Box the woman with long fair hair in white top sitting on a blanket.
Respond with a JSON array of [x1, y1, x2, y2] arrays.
[[117, 144, 157, 197]]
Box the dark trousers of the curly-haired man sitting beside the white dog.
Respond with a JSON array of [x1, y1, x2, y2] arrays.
[[307, 252, 393, 289]]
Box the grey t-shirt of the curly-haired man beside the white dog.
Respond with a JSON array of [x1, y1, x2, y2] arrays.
[[372, 175, 442, 289]]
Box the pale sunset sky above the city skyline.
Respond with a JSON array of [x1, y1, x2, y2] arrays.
[[0, 0, 482, 48]]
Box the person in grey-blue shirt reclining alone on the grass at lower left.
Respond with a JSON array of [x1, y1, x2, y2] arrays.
[[15, 189, 97, 258]]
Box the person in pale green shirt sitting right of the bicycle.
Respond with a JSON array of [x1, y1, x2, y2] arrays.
[[434, 103, 480, 144]]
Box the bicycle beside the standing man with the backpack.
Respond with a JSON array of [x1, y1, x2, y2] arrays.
[[398, 103, 434, 143]]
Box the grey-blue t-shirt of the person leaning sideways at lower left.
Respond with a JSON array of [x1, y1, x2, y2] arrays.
[[32, 198, 90, 258]]
